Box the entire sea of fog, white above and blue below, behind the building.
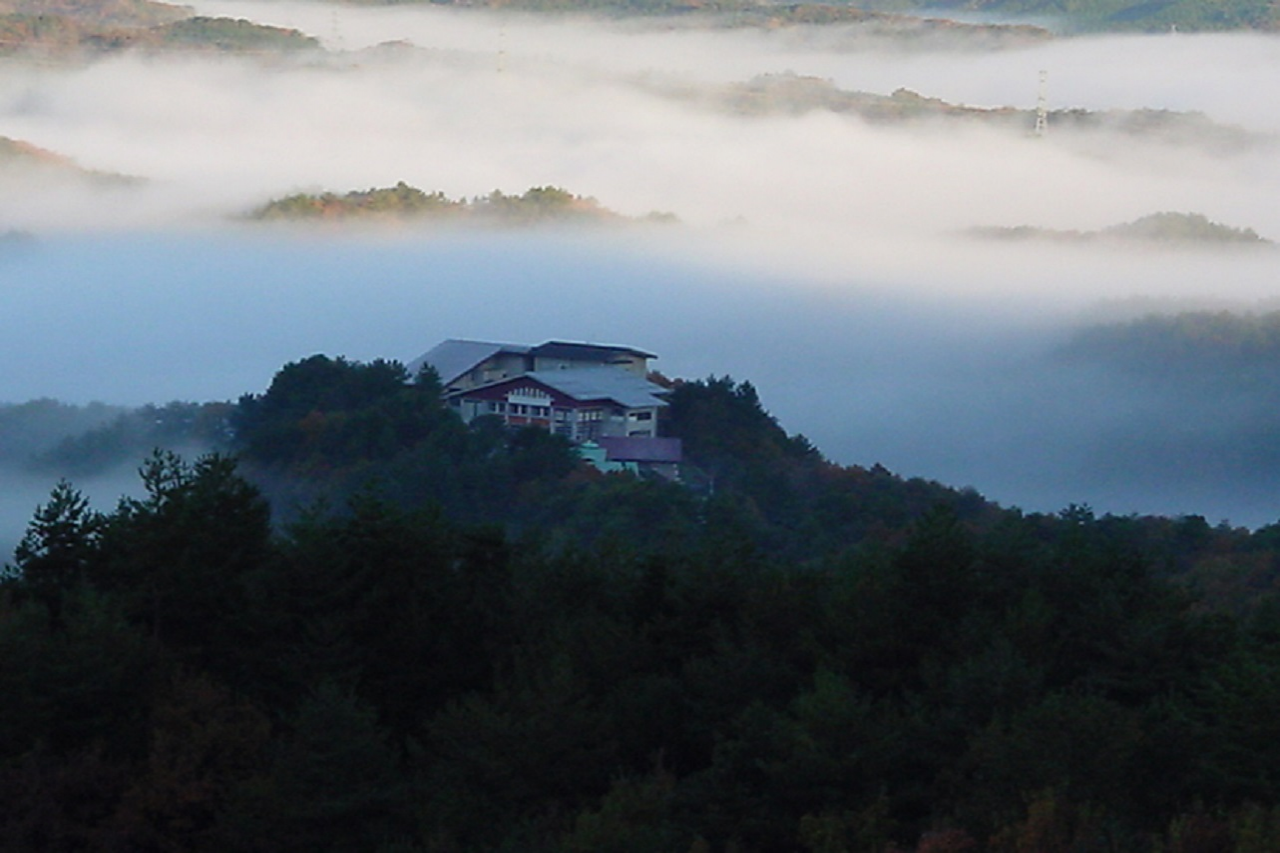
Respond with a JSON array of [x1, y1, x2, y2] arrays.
[[0, 0, 1280, 532]]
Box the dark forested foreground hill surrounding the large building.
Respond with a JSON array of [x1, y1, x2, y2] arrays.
[[0, 356, 1280, 853]]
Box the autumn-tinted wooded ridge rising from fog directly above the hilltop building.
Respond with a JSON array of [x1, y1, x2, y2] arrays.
[[248, 181, 675, 225]]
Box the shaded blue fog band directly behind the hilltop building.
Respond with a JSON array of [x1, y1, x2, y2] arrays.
[[0, 233, 1280, 524]]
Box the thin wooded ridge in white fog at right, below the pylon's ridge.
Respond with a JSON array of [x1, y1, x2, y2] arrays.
[[965, 213, 1275, 247]]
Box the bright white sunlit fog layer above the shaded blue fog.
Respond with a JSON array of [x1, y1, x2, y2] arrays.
[[0, 0, 1280, 252]]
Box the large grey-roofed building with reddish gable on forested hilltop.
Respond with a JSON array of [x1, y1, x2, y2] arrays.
[[408, 339, 681, 476]]
